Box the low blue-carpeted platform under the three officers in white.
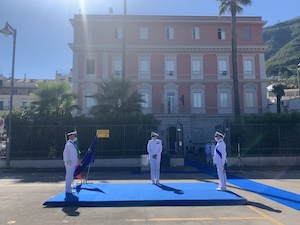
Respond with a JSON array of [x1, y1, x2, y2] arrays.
[[44, 182, 246, 207]]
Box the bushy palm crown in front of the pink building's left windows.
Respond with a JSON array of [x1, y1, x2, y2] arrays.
[[86, 79, 144, 117]]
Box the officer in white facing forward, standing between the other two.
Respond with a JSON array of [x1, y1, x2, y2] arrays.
[[147, 132, 162, 185]]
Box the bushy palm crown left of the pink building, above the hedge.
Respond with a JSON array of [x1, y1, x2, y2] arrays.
[[31, 81, 78, 121]]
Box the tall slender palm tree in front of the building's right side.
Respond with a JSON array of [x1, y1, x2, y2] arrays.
[[217, 0, 252, 116]]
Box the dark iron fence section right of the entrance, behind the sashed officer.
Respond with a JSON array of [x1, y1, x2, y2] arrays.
[[227, 124, 300, 156]]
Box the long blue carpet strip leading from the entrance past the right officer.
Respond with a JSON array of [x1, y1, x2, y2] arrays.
[[186, 161, 300, 211]]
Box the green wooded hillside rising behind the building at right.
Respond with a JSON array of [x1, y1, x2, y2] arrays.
[[263, 16, 300, 76]]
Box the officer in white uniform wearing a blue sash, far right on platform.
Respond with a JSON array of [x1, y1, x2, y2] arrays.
[[213, 132, 227, 191]]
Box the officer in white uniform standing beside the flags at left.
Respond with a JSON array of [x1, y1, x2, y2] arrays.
[[63, 131, 78, 196]]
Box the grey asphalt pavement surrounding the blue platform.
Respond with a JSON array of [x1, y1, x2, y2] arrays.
[[0, 163, 300, 225]]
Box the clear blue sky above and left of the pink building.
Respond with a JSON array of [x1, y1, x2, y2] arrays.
[[0, 0, 300, 79]]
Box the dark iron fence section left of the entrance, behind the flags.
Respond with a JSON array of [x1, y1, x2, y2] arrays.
[[11, 125, 157, 159]]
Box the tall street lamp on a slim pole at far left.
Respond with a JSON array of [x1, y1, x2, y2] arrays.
[[0, 22, 17, 169]]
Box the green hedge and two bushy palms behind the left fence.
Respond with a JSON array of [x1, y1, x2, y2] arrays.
[[2, 78, 159, 159]]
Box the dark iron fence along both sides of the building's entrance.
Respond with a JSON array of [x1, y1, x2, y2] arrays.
[[5, 124, 300, 159]]
